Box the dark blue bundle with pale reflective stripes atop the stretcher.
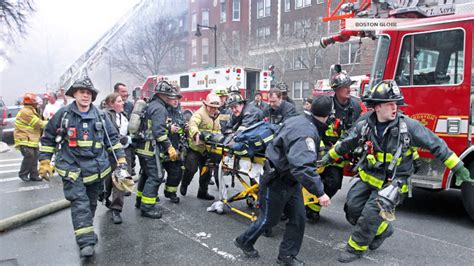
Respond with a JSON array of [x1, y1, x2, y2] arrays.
[[231, 121, 280, 157]]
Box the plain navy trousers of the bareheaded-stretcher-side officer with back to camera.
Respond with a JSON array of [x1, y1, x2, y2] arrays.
[[239, 177, 306, 256]]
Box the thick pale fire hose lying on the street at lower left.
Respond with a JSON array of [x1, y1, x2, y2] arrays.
[[0, 199, 71, 232]]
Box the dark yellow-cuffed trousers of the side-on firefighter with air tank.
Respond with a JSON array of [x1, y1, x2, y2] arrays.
[[137, 156, 163, 211]]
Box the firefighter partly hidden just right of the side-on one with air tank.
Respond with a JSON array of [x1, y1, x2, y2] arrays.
[[163, 87, 187, 203]]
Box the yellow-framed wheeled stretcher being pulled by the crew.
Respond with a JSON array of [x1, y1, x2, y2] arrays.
[[206, 143, 318, 221]]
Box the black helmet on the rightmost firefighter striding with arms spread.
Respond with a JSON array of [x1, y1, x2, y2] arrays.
[[362, 80, 404, 106]]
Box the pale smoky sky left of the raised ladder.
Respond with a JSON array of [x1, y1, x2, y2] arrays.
[[0, 0, 139, 105]]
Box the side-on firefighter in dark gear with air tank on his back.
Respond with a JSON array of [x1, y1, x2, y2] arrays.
[[135, 81, 179, 219]]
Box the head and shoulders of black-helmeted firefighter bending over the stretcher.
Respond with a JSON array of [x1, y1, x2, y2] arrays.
[[226, 94, 263, 133]]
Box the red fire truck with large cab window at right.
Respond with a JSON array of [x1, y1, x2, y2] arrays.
[[320, 0, 474, 220]]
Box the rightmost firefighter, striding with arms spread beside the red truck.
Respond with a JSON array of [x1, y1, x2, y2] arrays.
[[322, 80, 474, 263]]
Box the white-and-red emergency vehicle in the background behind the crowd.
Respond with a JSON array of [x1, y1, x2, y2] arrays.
[[140, 66, 272, 113]]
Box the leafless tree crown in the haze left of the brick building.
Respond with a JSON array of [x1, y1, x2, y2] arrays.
[[111, 16, 184, 79]]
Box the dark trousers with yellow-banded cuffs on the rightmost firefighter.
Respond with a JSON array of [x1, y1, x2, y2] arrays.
[[344, 180, 392, 253]]
